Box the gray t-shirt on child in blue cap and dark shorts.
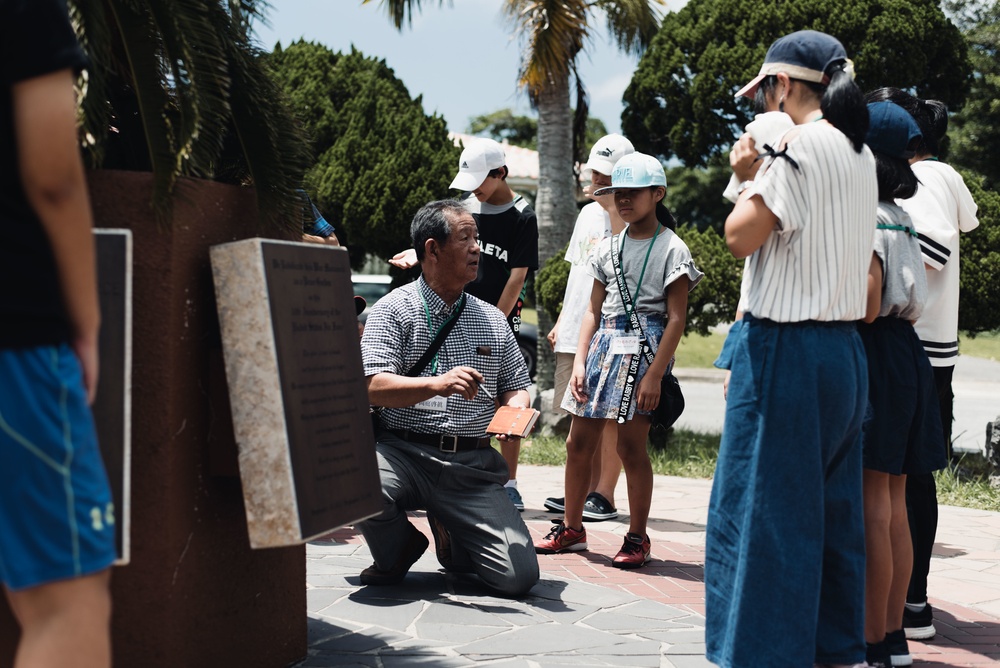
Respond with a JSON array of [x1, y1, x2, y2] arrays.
[[875, 202, 927, 320]]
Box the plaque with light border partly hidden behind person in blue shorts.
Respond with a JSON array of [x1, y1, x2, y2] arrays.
[[91, 229, 132, 565]]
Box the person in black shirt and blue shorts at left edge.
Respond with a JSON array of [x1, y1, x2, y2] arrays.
[[0, 0, 116, 668]]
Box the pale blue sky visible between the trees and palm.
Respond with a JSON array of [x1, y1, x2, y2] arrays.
[[256, 0, 684, 132]]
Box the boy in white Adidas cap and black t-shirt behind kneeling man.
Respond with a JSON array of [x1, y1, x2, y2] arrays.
[[389, 139, 538, 510]]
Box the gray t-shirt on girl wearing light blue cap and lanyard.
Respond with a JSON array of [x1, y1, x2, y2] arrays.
[[590, 228, 704, 316]]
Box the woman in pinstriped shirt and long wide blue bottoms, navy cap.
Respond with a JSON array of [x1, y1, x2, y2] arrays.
[[705, 30, 878, 668]]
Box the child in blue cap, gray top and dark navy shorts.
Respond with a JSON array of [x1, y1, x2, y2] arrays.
[[858, 101, 947, 668]]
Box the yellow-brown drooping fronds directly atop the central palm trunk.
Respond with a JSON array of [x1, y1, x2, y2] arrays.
[[503, 0, 589, 100]]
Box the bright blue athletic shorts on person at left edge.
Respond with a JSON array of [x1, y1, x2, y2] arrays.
[[0, 345, 116, 591]]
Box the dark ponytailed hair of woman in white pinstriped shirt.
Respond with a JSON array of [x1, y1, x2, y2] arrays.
[[754, 60, 868, 153]]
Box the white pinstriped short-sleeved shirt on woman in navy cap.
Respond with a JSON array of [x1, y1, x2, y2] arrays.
[[745, 122, 878, 322]]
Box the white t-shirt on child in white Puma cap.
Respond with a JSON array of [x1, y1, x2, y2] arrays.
[[555, 202, 611, 354]]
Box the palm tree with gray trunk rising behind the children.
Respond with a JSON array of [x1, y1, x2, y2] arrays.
[[363, 0, 663, 385]]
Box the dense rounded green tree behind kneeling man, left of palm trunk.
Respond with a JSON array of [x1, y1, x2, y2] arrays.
[[268, 41, 460, 267]]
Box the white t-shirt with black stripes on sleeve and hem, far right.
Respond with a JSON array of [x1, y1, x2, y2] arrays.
[[896, 160, 979, 367]]
